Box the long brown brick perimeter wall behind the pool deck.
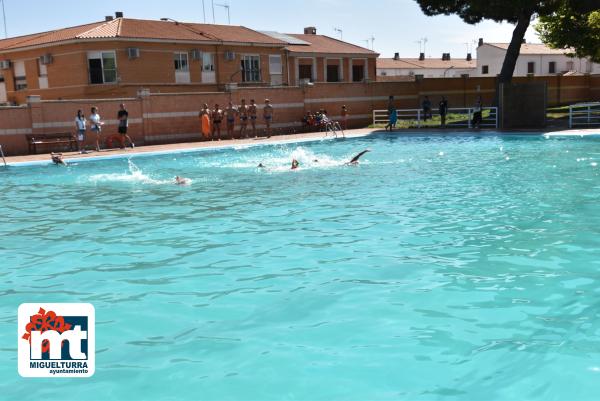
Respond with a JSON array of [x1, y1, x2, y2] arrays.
[[0, 76, 600, 155]]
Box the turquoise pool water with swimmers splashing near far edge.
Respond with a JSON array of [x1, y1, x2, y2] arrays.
[[0, 135, 600, 401]]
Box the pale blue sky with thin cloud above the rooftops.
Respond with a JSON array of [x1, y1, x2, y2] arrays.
[[0, 0, 539, 58]]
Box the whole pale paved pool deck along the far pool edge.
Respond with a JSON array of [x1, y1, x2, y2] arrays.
[[0, 128, 600, 165]]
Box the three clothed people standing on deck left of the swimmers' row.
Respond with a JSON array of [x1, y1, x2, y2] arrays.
[[75, 103, 135, 153]]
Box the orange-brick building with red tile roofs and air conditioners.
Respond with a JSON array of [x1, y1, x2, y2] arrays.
[[0, 13, 378, 103]]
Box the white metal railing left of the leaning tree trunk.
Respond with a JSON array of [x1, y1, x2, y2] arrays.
[[373, 107, 498, 128]]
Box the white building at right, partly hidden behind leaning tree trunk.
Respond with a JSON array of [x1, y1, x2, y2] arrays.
[[474, 39, 600, 77]]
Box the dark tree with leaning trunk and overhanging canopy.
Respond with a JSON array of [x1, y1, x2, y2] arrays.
[[416, 0, 564, 83]]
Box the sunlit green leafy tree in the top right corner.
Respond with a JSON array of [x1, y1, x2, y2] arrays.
[[535, 0, 600, 63]]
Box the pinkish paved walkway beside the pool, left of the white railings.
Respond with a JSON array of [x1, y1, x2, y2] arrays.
[[0, 128, 374, 164]]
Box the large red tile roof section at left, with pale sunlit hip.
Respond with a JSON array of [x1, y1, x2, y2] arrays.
[[0, 18, 287, 51]]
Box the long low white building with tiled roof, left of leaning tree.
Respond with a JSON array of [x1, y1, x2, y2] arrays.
[[377, 53, 477, 80]]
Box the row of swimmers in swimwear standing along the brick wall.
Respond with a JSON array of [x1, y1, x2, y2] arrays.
[[198, 99, 274, 141]]
